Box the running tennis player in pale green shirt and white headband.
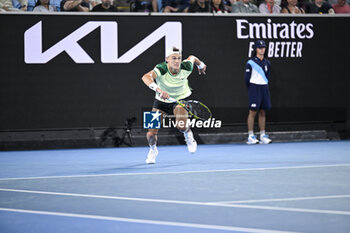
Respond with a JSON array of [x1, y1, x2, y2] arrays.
[[142, 47, 207, 164]]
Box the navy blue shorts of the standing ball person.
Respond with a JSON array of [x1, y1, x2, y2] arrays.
[[248, 83, 271, 111]]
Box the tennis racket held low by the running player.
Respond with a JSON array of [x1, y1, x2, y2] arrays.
[[168, 97, 212, 121]]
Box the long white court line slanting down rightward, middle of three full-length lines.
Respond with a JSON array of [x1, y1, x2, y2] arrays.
[[0, 188, 350, 215]]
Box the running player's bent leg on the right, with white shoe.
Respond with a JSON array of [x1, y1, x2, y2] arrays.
[[174, 105, 197, 153]]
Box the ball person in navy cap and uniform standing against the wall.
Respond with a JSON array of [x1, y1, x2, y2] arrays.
[[245, 40, 271, 144]]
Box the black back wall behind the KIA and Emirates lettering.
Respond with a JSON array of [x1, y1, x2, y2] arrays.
[[0, 14, 350, 131]]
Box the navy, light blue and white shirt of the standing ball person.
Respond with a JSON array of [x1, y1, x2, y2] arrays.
[[244, 56, 271, 87]]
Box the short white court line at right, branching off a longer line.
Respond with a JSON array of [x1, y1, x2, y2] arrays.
[[208, 195, 350, 204]]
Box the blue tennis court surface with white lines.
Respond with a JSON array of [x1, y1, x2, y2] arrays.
[[0, 141, 350, 233]]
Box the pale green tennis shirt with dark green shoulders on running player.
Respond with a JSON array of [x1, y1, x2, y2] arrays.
[[153, 60, 193, 103]]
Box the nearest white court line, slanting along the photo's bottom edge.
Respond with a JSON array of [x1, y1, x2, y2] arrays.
[[0, 208, 297, 233]]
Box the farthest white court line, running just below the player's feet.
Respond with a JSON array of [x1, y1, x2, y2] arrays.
[[0, 163, 350, 181]]
